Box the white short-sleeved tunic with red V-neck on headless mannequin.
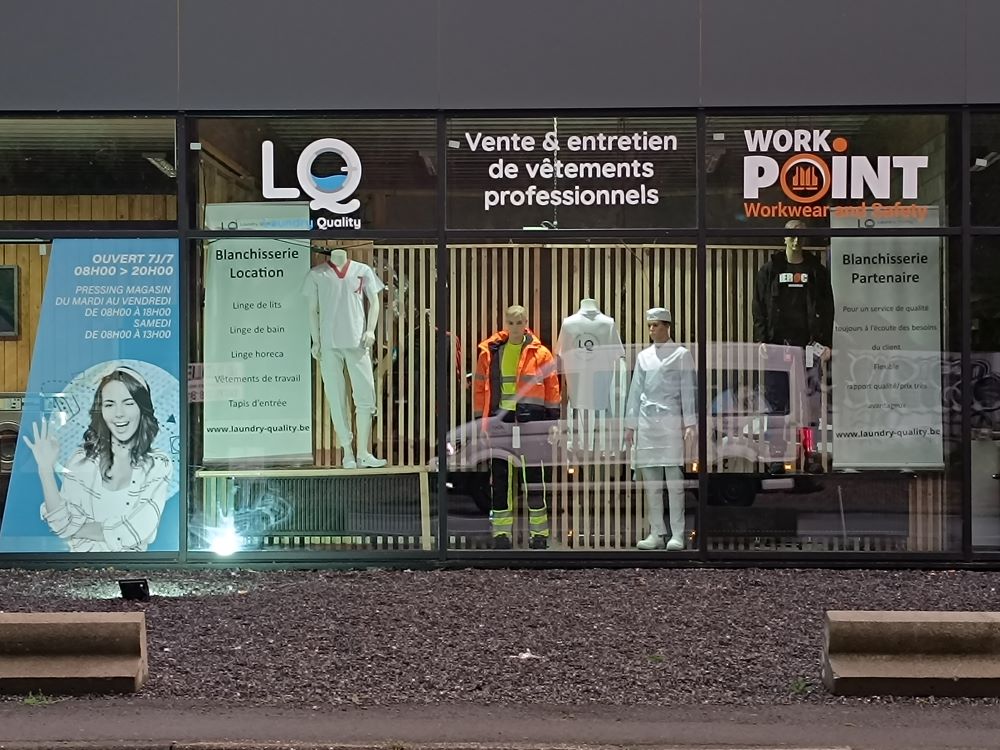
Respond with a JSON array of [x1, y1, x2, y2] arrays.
[[302, 260, 385, 349]]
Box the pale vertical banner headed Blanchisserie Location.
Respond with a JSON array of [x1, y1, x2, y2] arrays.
[[203, 203, 312, 463]]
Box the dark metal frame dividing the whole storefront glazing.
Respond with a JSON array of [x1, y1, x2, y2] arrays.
[[0, 105, 1000, 568]]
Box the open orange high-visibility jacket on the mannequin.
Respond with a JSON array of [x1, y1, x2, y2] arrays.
[[472, 330, 560, 422]]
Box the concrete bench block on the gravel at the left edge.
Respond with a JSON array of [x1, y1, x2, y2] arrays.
[[0, 612, 149, 695]]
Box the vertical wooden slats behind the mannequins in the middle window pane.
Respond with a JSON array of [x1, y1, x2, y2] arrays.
[[449, 245, 712, 549]]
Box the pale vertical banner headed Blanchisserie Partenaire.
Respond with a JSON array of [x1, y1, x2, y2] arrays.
[[830, 207, 944, 469]]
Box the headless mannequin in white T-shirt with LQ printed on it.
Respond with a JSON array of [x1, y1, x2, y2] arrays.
[[555, 298, 625, 450]]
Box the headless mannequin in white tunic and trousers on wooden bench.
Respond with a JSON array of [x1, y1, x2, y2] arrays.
[[302, 248, 386, 469]]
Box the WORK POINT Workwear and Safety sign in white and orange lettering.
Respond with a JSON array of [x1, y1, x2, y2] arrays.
[[743, 129, 928, 219]]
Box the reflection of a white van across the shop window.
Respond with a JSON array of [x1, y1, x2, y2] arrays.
[[442, 343, 826, 512]]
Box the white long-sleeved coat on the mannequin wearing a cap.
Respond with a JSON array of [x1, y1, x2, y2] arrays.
[[625, 341, 698, 468]]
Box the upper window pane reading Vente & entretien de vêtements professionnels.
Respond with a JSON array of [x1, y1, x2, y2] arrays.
[[448, 116, 696, 230]]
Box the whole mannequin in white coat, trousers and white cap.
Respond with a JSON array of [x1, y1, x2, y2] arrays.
[[625, 307, 698, 550]]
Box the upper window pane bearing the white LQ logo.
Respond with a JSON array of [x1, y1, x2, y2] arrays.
[[194, 117, 438, 236]]
